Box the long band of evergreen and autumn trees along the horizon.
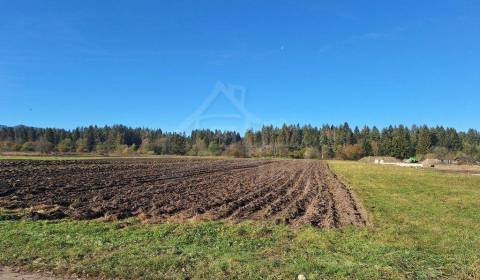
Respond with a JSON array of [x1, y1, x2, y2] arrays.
[[0, 123, 480, 161]]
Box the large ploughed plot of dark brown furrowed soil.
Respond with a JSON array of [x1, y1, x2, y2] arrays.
[[0, 158, 366, 228]]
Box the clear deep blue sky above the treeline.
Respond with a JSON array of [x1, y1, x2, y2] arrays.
[[0, 0, 480, 130]]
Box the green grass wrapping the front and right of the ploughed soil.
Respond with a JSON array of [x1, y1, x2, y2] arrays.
[[0, 161, 480, 279]]
